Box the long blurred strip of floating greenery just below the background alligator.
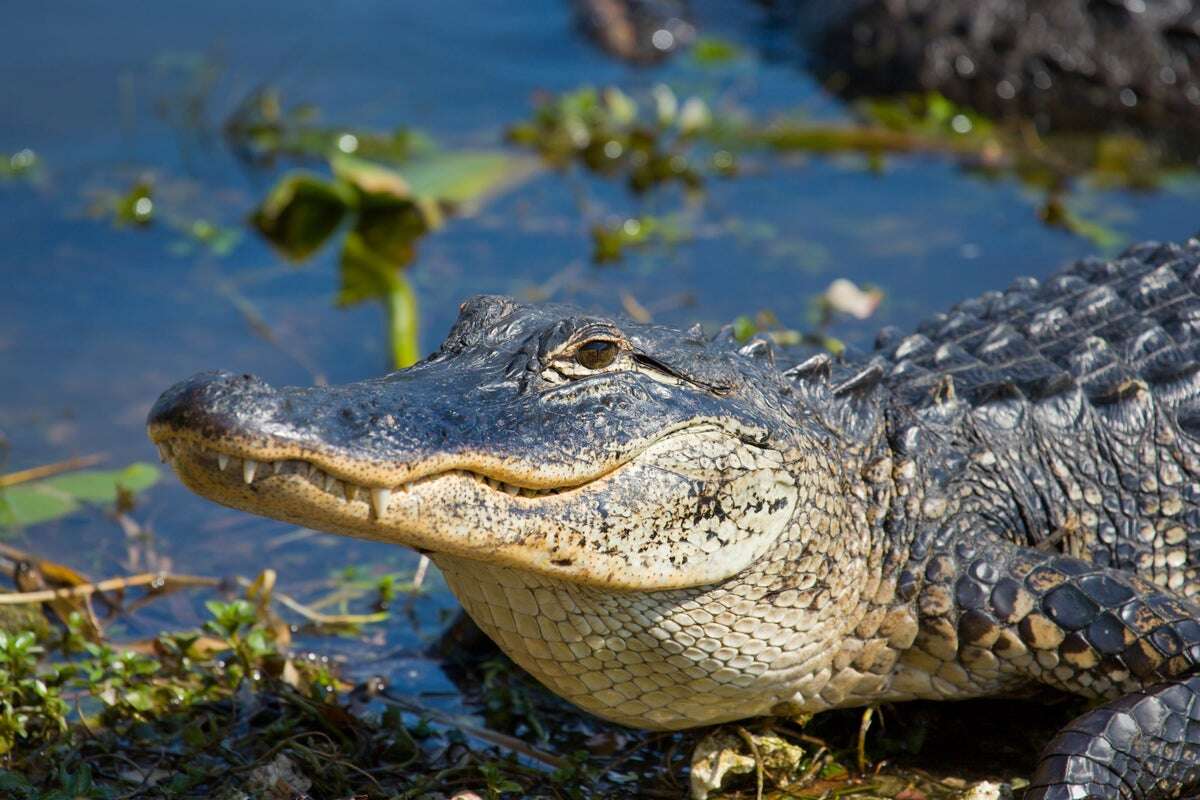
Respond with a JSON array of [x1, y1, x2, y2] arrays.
[[509, 81, 1193, 256]]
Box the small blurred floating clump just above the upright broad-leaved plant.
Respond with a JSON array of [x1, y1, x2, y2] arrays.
[[224, 86, 433, 166]]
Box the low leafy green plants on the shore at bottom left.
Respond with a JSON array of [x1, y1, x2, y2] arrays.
[[0, 600, 628, 800]]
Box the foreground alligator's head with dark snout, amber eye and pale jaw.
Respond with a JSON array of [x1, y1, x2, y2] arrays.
[[149, 297, 878, 727]]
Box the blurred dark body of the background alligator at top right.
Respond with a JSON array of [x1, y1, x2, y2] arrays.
[[806, 0, 1200, 137]]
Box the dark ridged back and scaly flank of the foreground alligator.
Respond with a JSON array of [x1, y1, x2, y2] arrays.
[[874, 240, 1200, 594]]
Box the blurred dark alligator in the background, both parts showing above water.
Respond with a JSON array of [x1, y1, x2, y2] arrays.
[[571, 0, 1200, 143]]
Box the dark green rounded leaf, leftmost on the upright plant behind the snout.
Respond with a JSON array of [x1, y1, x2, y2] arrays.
[[251, 172, 356, 261]]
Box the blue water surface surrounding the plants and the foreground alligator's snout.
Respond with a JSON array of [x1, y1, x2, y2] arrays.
[[0, 0, 1200, 729]]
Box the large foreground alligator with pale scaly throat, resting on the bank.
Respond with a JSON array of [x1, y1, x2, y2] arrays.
[[148, 239, 1200, 800]]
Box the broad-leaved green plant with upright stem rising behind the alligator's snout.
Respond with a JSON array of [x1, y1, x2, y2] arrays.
[[251, 151, 534, 368]]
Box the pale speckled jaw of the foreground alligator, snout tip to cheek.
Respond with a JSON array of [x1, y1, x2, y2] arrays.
[[150, 423, 796, 590]]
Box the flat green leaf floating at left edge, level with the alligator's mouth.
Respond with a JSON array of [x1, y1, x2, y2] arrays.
[[0, 462, 160, 527]]
